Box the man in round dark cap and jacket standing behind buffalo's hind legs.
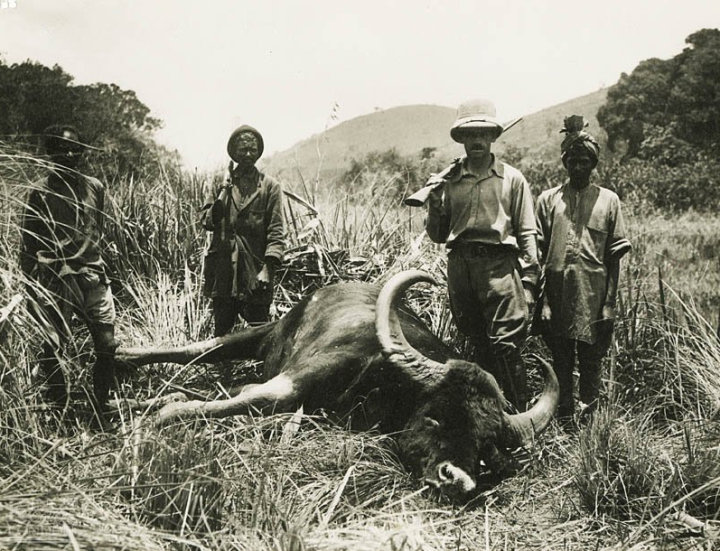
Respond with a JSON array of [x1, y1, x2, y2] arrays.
[[201, 125, 285, 344]]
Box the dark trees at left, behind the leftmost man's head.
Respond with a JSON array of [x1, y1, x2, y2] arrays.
[[0, 58, 179, 183]]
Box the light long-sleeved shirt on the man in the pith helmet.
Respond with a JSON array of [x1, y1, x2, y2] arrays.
[[425, 156, 539, 286]]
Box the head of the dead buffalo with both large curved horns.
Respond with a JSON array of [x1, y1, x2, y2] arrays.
[[376, 271, 559, 495]]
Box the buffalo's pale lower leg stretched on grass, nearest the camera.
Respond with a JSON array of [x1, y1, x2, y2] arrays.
[[154, 374, 299, 426]]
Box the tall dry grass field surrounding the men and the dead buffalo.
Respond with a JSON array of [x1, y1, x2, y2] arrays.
[[0, 149, 720, 551]]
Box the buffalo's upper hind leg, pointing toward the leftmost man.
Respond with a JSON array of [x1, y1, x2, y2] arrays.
[[115, 321, 277, 367]]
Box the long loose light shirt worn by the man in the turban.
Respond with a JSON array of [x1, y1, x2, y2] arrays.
[[537, 184, 631, 344]]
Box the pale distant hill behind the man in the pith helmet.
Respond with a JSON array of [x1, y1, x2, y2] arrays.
[[263, 88, 607, 181]]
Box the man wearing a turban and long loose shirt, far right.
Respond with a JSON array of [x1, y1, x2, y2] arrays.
[[536, 115, 631, 421]]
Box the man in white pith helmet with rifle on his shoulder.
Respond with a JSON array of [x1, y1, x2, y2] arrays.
[[425, 99, 538, 410]]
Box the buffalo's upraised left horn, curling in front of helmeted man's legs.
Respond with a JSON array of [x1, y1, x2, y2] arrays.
[[375, 270, 443, 379]]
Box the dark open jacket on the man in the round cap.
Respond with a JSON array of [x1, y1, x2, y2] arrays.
[[201, 169, 285, 304]]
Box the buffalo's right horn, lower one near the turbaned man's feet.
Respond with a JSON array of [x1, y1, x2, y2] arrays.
[[504, 354, 560, 448]]
